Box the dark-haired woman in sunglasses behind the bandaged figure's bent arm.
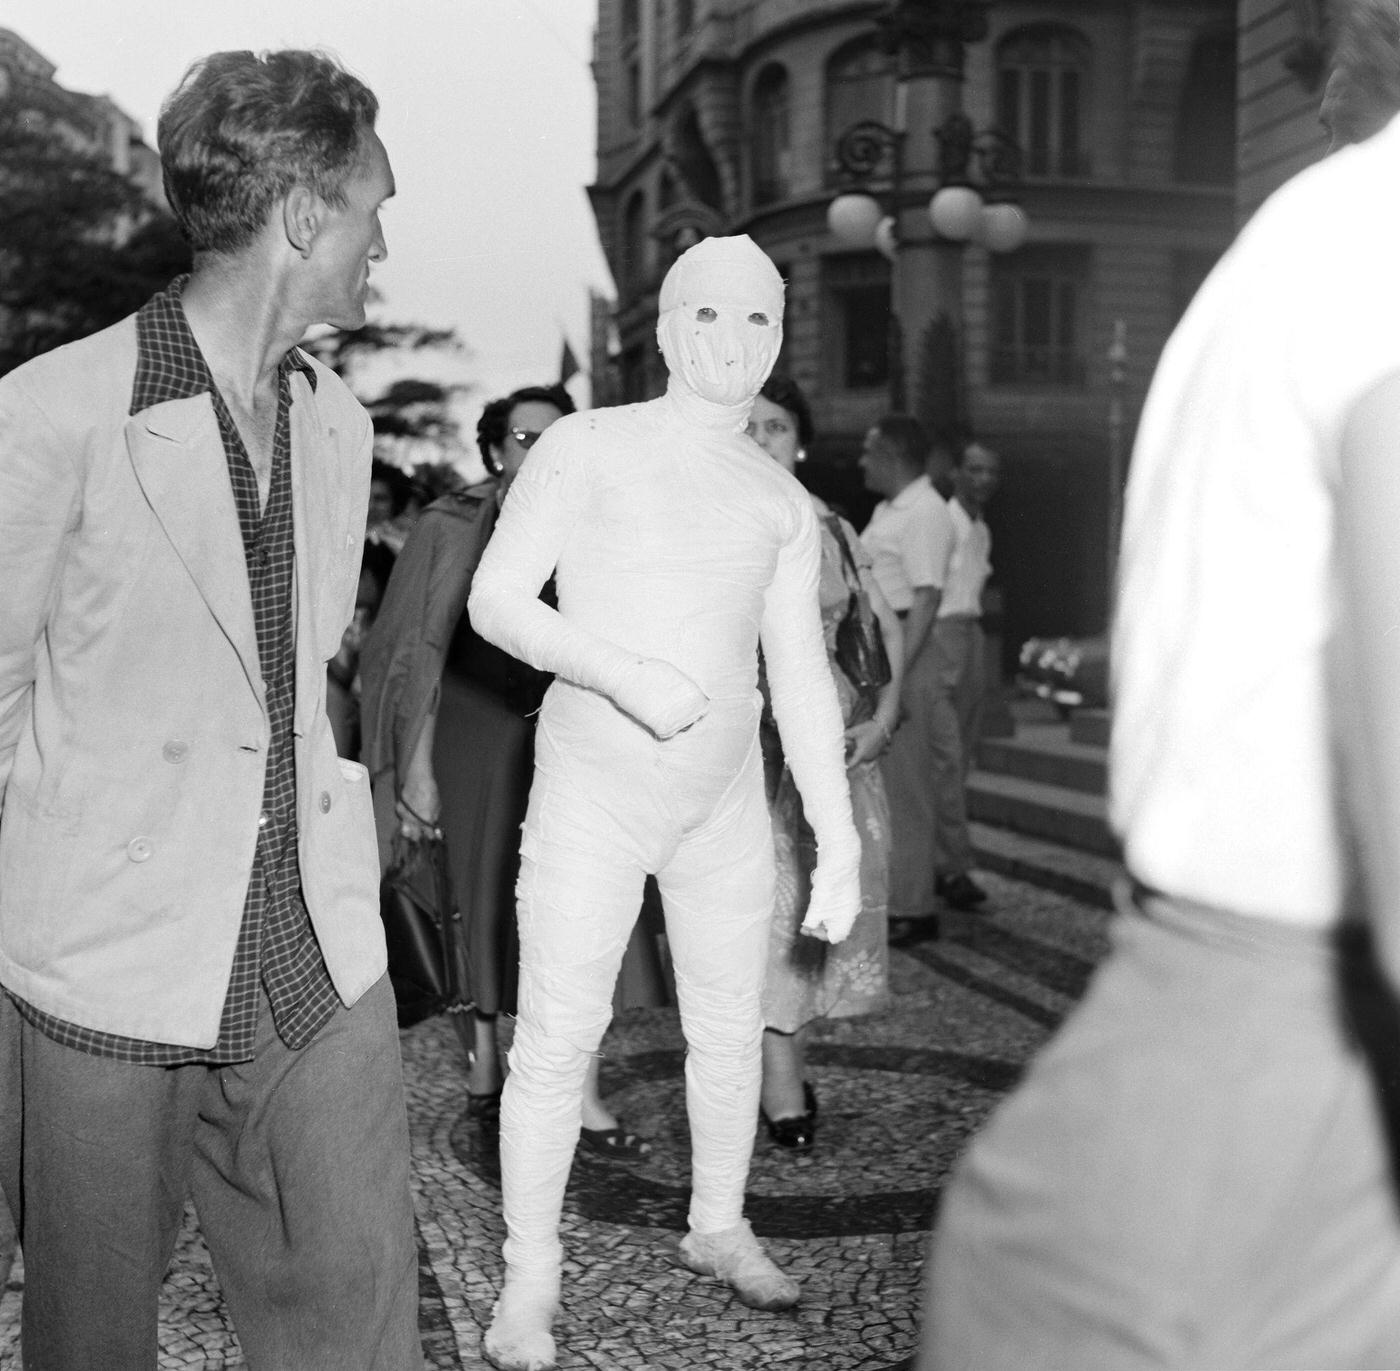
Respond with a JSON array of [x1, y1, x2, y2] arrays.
[[361, 385, 664, 1161]]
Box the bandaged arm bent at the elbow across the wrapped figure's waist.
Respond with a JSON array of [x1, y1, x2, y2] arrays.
[[468, 431, 710, 738]]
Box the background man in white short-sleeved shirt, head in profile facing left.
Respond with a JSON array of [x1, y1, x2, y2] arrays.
[[860, 415, 958, 919]]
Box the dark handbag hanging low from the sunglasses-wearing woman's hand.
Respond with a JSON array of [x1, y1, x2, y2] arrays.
[[379, 833, 473, 1028]]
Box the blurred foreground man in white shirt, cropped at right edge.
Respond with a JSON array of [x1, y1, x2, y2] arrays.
[[918, 18, 1400, 1371]]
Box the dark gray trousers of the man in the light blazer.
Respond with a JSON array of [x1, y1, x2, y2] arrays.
[[0, 977, 423, 1371]]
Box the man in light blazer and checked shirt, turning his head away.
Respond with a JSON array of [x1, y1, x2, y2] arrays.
[[0, 52, 421, 1371]]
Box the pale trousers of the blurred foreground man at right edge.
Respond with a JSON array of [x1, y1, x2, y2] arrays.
[[918, 898, 1400, 1371]]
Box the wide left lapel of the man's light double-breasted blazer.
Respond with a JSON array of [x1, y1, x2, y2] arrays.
[[126, 395, 262, 700]]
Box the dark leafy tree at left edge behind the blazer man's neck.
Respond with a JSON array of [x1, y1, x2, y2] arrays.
[[0, 101, 189, 374]]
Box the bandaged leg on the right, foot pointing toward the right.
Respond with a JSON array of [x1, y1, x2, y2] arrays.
[[658, 752, 799, 1309]]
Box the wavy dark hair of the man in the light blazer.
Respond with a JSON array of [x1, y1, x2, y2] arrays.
[[157, 49, 379, 252]]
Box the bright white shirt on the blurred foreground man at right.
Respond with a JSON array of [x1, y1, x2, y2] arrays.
[[1110, 122, 1400, 926]]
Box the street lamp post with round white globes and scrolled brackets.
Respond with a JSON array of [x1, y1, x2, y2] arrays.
[[827, 0, 1029, 409]]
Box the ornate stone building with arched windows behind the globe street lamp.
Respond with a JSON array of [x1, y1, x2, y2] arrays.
[[591, 0, 1236, 657]]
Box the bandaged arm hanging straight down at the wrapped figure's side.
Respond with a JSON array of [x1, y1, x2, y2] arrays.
[[759, 500, 861, 942]]
